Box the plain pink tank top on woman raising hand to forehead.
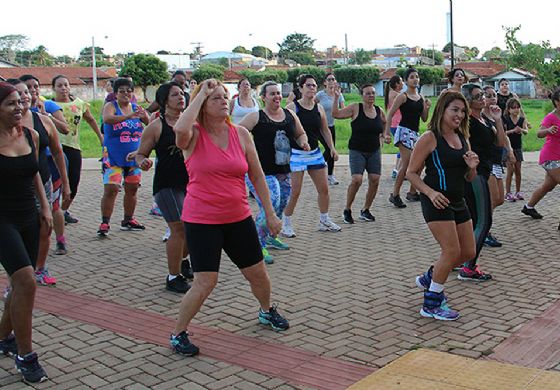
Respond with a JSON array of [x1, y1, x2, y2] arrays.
[[181, 124, 251, 225]]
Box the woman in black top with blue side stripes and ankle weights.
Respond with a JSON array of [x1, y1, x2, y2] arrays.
[[407, 92, 478, 321]]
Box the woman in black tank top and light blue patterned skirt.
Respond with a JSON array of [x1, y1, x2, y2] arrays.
[[281, 74, 340, 237]]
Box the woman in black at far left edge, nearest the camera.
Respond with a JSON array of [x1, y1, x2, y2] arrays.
[[0, 82, 52, 382]]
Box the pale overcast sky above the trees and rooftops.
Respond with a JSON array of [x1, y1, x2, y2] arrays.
[[0, 0, 560, 57]]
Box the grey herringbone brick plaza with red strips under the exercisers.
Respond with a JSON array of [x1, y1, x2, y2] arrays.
[[0, 153, 560, 390]]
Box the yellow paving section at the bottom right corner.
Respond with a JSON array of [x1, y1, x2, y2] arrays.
[[348, 349, 560, 390]]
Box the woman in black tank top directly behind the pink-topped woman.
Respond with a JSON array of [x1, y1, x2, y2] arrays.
[[134, 81, 192, 293]]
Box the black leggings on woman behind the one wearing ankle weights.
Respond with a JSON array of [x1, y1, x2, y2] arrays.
[[465, 175, 492, 269]]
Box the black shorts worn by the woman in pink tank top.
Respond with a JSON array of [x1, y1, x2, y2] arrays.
[[185, 216, 263, 272]]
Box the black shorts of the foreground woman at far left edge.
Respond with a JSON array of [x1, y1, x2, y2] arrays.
[[0, 218, 39, 276]]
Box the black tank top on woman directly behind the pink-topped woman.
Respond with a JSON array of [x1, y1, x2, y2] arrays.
[[153, 115, 189, 195]]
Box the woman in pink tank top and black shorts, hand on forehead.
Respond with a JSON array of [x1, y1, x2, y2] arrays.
[[166, 79, 289, 356]]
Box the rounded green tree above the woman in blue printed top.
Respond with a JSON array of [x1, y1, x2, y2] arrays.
[[120, 54, 169, 99]]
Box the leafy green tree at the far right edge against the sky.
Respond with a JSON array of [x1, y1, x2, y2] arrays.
[[503, 26, 560, 87]]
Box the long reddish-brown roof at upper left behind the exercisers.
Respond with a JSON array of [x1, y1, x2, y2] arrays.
[[0, 66, 117, 85]]
